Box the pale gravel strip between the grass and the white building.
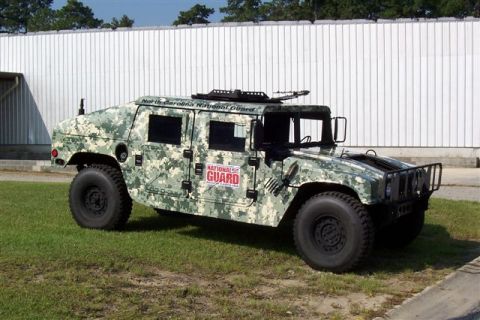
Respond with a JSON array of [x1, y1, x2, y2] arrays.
[[0, 168, 480, 201]]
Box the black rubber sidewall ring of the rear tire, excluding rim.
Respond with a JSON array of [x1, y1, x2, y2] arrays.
[[70, 168, 120, 229]]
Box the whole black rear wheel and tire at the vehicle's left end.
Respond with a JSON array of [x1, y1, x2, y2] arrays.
[[69, 164, 132, 230]]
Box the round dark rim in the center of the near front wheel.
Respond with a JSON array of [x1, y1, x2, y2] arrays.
[[313, 217, 347, 254]]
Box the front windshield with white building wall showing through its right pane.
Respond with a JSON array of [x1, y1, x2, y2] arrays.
[[259, 112, 334, 148]]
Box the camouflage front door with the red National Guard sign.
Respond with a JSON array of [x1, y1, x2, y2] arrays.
[[192, 111, 256, 206]]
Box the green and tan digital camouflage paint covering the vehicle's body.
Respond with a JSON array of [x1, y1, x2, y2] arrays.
[[52, 97, 394, 226]]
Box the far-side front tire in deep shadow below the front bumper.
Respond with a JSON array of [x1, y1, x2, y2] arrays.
[[377, 210, 425, 249]]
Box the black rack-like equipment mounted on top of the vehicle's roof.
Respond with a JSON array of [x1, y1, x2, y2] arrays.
[[192, 89, 310, 103]]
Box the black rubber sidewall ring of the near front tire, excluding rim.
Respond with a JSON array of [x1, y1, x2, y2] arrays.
[[295, 196, 363, 270]]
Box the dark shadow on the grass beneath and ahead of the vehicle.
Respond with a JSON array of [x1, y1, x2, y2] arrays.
[[126, 213, 480, 273]]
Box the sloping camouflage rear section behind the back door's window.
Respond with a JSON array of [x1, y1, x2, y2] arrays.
[[53, 103, 138, 140]]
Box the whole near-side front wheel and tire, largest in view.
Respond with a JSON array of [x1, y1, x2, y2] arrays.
[[293, 192, 375, 272]]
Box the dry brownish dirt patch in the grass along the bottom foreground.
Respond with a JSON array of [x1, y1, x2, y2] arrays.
[[86, 269, 391, 319]]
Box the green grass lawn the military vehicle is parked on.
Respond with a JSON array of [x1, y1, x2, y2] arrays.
[[0, 182, 480, 319]]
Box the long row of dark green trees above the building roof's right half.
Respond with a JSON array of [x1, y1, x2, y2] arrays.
[[220, 0, 480, 22]]
